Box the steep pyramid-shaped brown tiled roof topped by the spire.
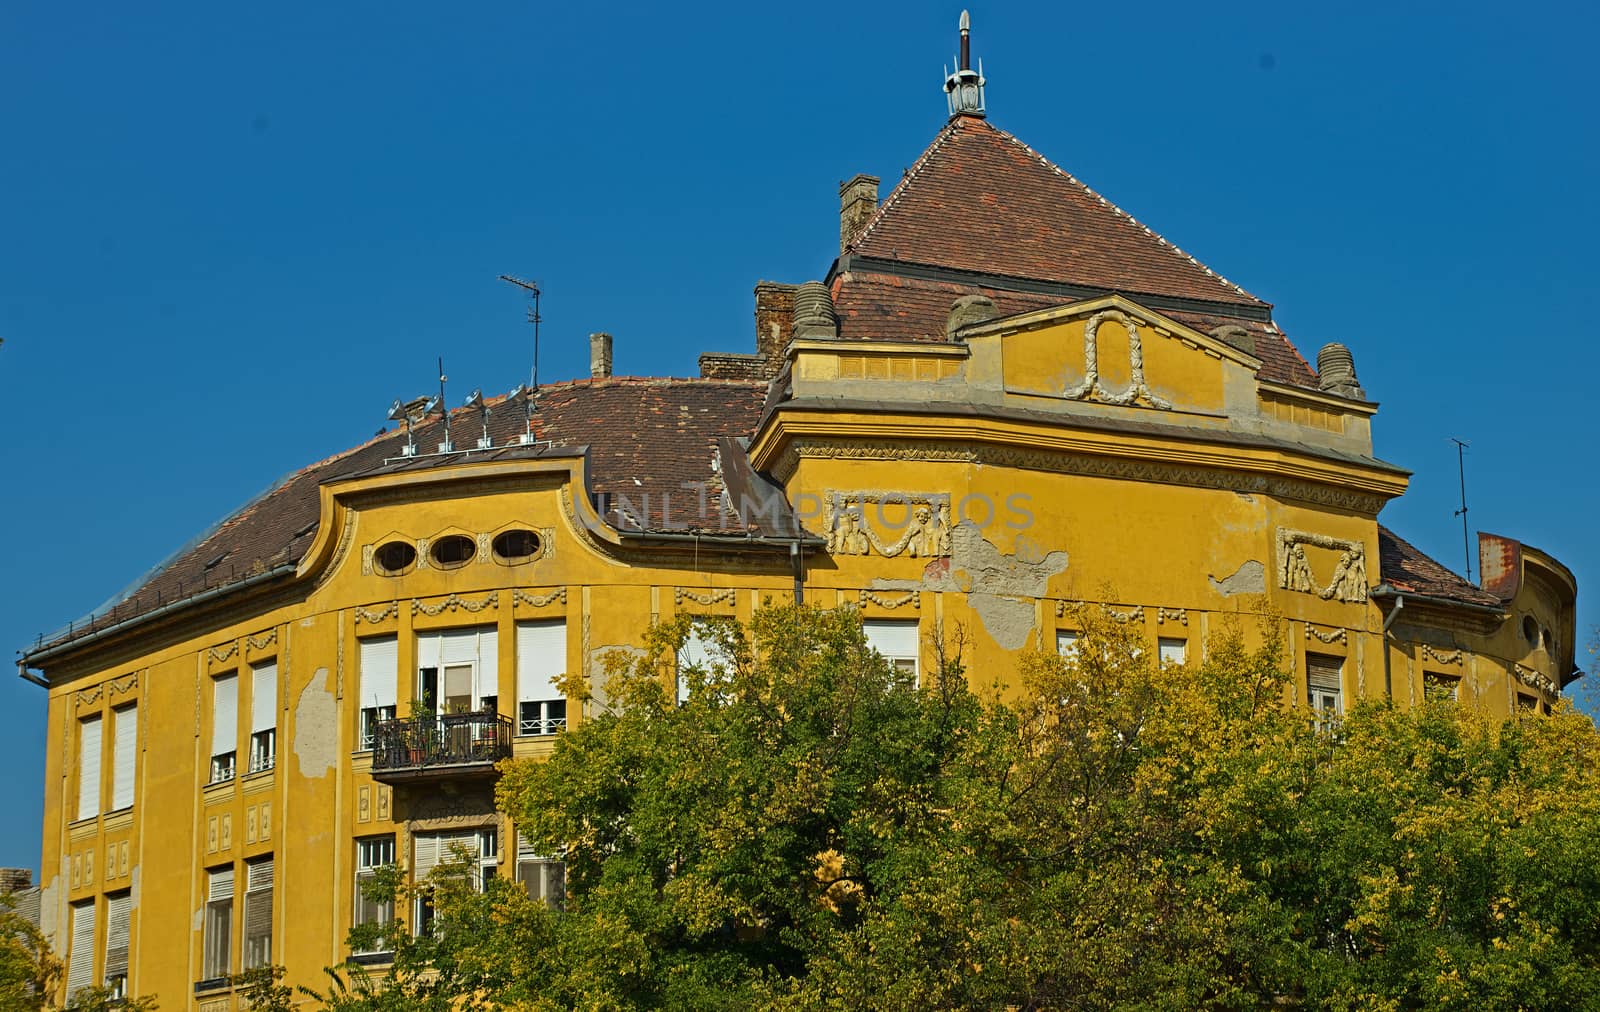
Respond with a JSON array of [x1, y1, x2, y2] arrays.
[[850, 117, 1266, 307]]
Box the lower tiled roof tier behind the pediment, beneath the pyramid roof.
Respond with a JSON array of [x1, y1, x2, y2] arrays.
[[834, 272, 1317, 386]]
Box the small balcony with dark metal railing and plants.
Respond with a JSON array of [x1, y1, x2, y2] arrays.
[[373, 713, 512, 785]]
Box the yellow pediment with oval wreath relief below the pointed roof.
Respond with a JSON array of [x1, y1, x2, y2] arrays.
[[960, 295, 1261, 415]]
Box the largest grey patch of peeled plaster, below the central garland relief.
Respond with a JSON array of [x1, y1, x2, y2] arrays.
[[872, 520, 1067, 650]]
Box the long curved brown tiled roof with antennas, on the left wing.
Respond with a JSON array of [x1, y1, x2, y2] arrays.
[[29, 378, 766, 653]]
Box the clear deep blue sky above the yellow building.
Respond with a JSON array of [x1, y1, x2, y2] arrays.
[[0, 0, 1600, 866]]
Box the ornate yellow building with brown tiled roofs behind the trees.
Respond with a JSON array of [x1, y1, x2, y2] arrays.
[[12, 21, 1576, 1012]]
